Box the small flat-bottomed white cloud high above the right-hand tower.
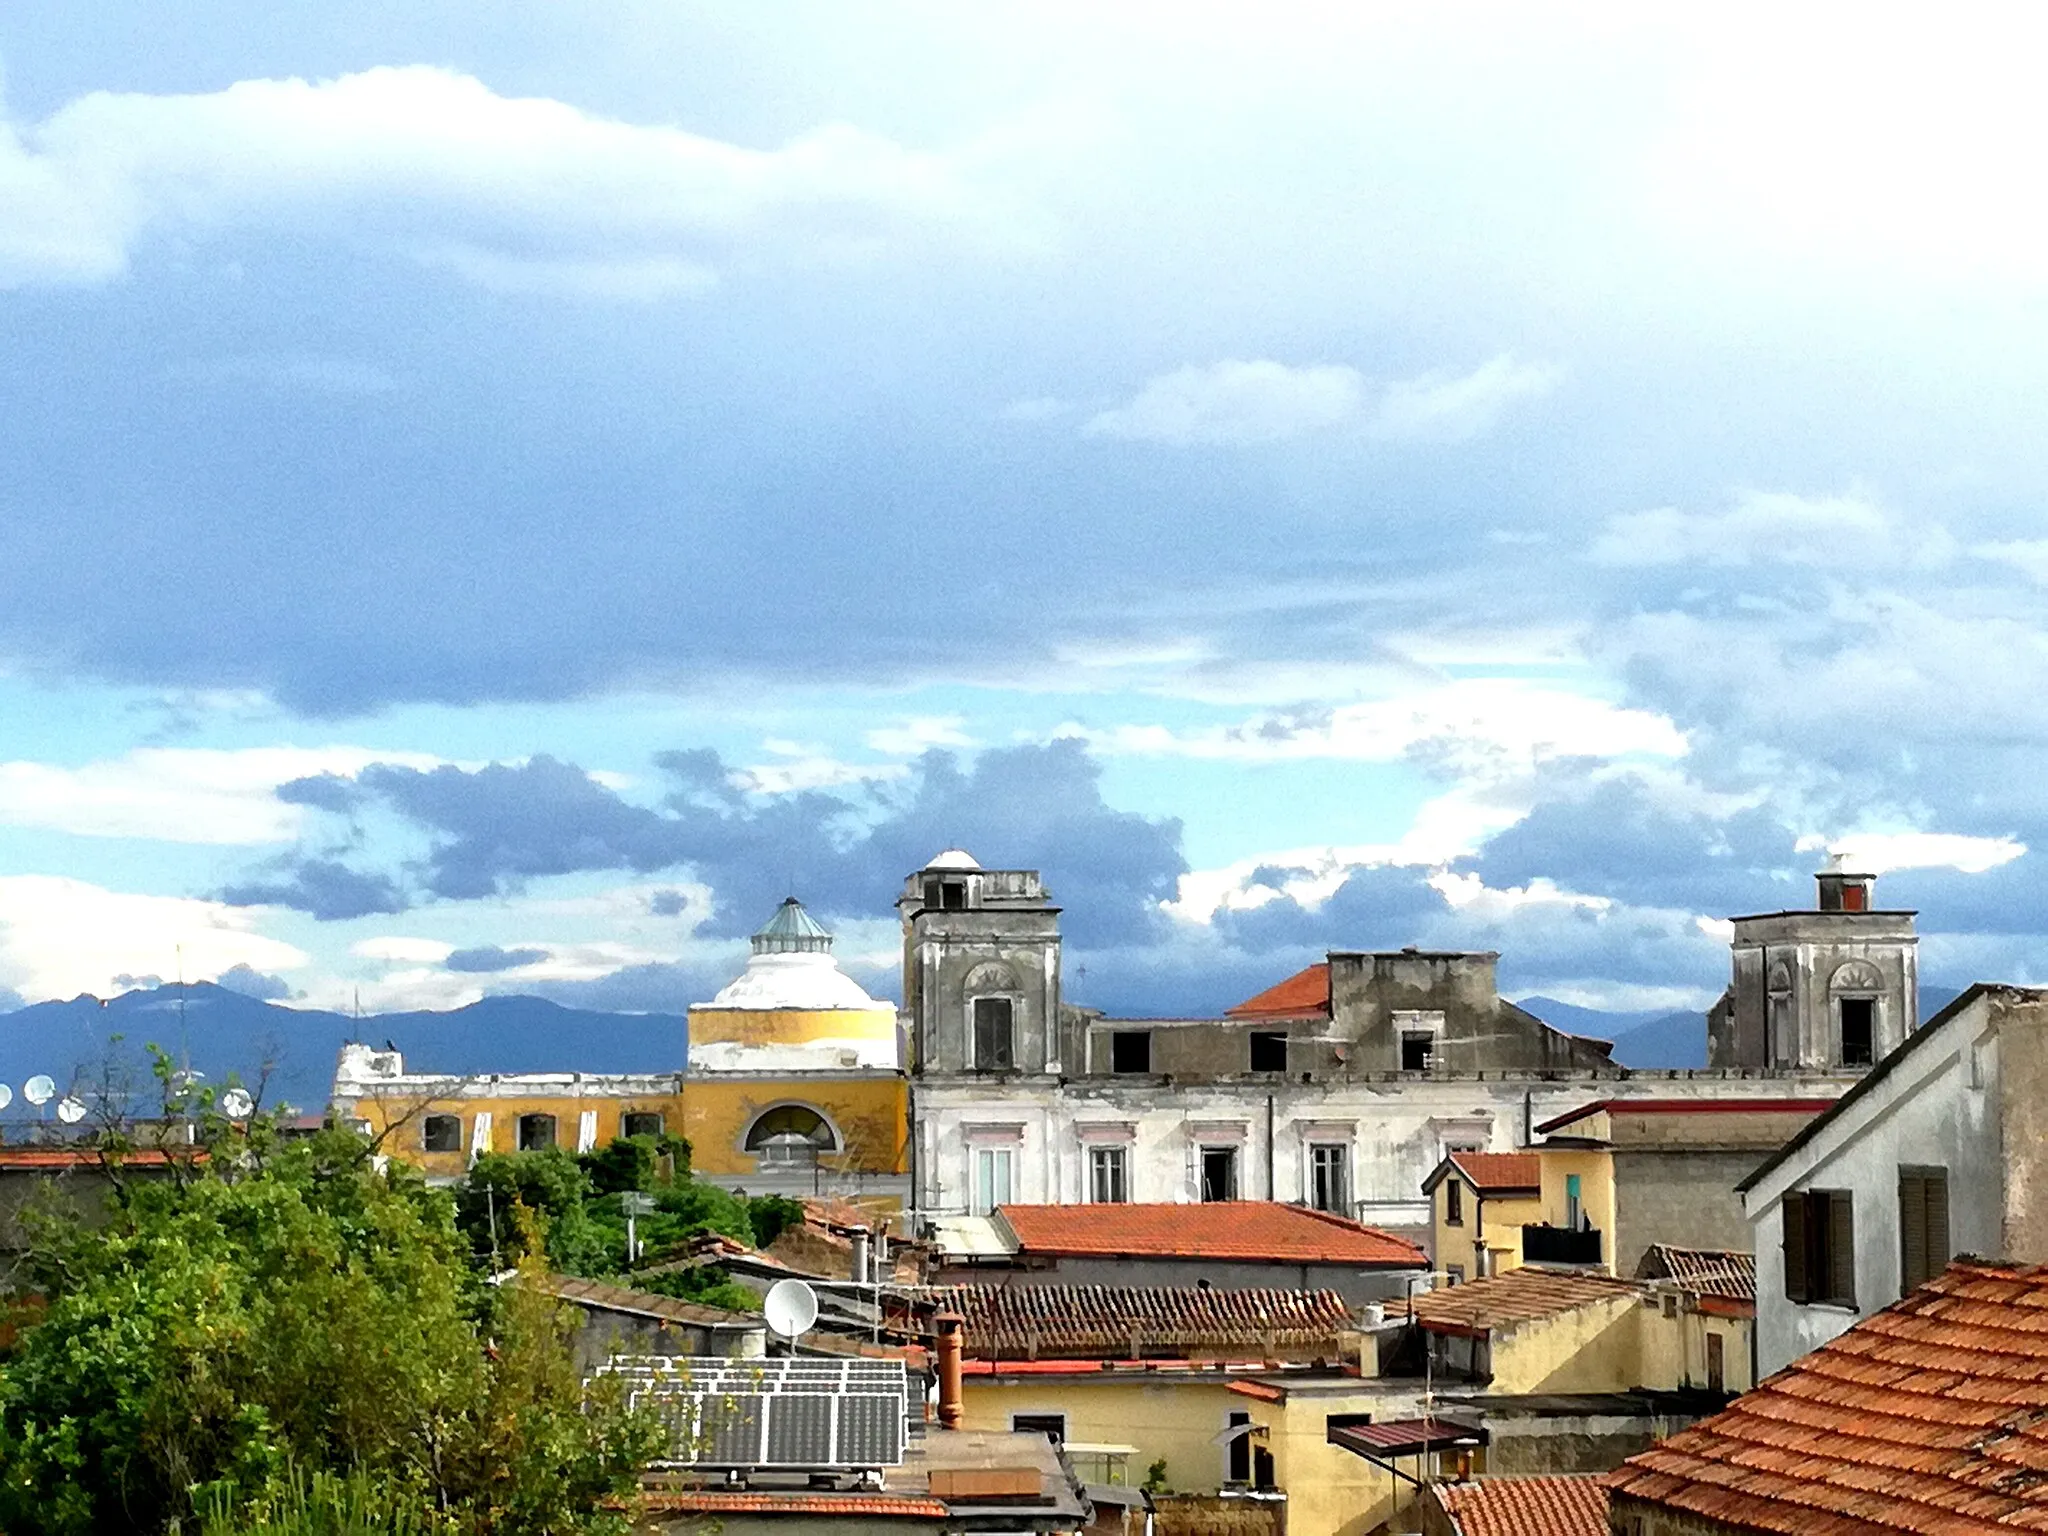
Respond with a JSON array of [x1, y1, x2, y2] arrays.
[[1591, 492, 1956, 569]]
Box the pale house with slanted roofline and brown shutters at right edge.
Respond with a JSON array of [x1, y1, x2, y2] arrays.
[[1741, 985, 2048, 1374]]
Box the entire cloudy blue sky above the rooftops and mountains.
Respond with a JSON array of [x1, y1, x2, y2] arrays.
[[0, 0, 2048, 1028]]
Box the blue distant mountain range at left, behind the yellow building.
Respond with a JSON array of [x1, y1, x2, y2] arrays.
[[0, 981, 690, 1120]]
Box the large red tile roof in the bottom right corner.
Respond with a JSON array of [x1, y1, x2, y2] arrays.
[[1606, 1262, 2048, 1536]]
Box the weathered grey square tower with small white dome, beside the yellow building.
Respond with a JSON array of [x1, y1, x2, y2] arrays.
[[897, 848, 1063, 1075]]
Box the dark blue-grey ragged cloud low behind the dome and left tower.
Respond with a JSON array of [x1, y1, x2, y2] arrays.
[[235, 741, 1186, 944]]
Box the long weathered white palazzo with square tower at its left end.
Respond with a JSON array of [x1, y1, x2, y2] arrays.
[[897, 850, 1875, 1231]]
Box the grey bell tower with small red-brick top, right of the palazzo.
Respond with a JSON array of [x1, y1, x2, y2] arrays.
[[1706, 858, 1919, 1073]]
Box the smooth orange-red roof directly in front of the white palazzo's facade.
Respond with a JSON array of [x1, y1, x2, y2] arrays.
[[995, 1200, 1430, 1270]]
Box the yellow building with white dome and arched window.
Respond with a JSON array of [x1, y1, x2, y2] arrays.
[[334, 897, 909, 1206]]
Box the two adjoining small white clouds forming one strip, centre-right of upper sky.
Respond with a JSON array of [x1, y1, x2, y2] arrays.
[[1081, 352, 1559, 446]]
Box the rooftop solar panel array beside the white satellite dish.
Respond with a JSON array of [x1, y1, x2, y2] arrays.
[[606, 1356, 918, 1470]]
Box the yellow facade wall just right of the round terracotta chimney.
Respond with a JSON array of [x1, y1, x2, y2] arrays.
[[963, 1372, 1264, 1493]]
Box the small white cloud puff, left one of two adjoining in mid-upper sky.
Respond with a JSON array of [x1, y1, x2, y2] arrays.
[[1081, 360, 1366, 444]]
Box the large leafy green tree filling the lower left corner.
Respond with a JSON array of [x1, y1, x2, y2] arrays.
[[0, 1063, 659, 1536]]
